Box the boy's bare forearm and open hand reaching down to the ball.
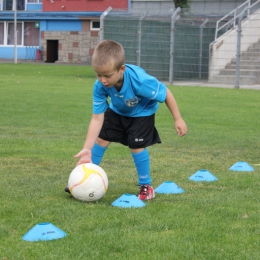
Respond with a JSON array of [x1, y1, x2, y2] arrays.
[[74, 113, 104, 165]]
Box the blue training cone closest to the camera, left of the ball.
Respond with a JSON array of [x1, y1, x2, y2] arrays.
[[22, 222, 67, 242]]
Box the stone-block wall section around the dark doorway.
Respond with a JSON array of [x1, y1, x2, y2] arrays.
[[41, 20, 99, 64]]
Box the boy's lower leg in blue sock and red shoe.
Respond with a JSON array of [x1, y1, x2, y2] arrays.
[[131, 148, 155, 200]]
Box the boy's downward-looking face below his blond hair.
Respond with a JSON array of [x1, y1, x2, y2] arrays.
[[93, 65, 125, 88]]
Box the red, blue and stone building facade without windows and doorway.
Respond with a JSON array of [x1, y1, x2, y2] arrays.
[[0, 0, 128, 63]]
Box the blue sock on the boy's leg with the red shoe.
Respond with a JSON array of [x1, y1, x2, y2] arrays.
[[132, 149, 152, 185]]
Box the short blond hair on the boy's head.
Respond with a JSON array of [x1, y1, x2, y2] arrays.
[[92, 40, 125, 70]]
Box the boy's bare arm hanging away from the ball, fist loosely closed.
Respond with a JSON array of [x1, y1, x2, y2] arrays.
[[165, 88, 187, 136]]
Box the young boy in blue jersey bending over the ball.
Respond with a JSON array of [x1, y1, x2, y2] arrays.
[[65, 40, 187, 200]]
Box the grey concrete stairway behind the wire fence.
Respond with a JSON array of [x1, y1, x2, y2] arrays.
[[210, 41, 260, 85]]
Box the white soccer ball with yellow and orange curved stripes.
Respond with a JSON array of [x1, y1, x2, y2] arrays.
[[68, 163, 108, 201]]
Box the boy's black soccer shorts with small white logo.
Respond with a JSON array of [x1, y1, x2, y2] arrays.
[[99, 108, 161, 149]]
